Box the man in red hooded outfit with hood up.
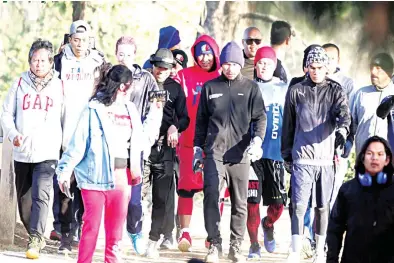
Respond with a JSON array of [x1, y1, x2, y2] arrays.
[[176, 35, 220, 252]]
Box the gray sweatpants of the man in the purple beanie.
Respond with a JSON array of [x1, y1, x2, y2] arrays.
[[204, 159, 250, 244]]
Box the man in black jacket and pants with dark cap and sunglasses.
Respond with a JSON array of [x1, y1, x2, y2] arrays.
[[144, 48, 190, 258]]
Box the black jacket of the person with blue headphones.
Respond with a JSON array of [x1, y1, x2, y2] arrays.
[[327, 177, 394, 263]]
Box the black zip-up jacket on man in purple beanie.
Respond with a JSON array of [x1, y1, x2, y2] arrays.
[[194, 73, 267, 163]]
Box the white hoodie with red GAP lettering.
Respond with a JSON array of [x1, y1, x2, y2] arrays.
[[1, 72, 64, 163]]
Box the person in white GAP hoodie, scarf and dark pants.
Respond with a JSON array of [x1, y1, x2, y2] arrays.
[[1, 39, 64, 259]]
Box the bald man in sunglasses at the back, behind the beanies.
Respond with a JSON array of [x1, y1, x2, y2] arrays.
[[241, 27, 262, 80]]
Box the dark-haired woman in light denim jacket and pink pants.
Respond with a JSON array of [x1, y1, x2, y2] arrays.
[[56, 65, 146, 263]]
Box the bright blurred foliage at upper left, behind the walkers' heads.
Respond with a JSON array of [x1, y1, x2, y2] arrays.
[[0, 1, 204, 102]]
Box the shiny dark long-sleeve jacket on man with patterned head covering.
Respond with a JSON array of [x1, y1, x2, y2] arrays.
[[281, 77, 351, 165]]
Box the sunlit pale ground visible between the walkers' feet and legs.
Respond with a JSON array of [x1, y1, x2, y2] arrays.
[[0, 194, 310, 263]]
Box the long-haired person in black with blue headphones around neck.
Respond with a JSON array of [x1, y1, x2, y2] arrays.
[[327, 136, 394, 263]]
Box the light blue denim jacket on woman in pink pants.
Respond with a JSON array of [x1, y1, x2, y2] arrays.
[[56, 101, 148, 191]]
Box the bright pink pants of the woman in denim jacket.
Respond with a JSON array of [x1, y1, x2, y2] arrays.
[[78, 169, 131, 263]]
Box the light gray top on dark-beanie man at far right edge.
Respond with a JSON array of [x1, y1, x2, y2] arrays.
[[350, 82, 394, 155]]
